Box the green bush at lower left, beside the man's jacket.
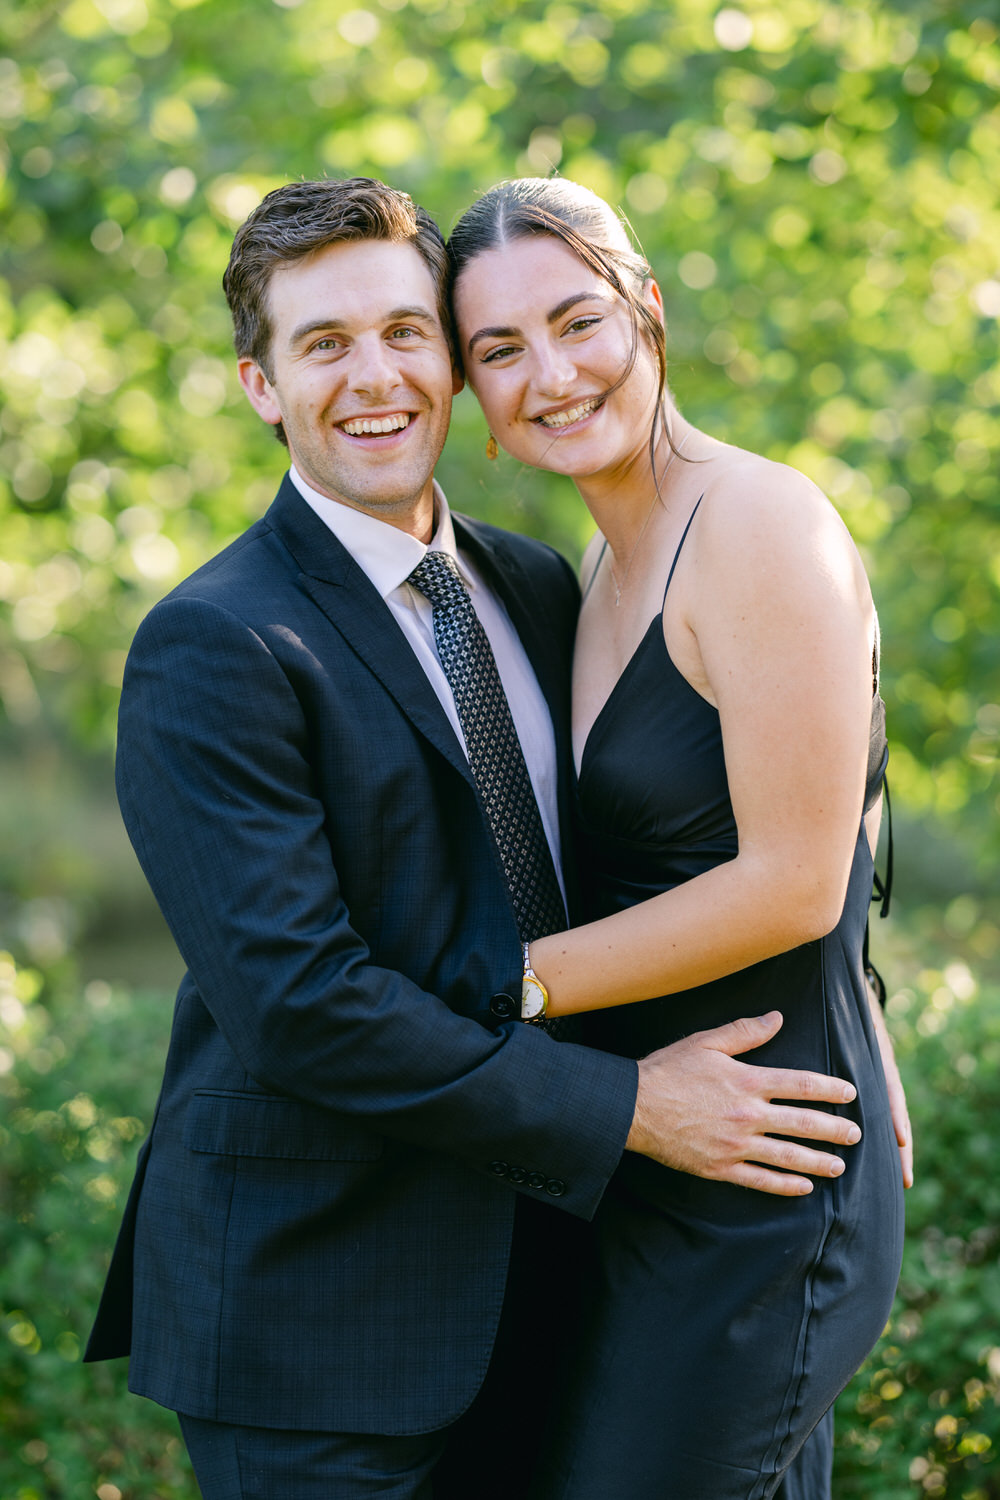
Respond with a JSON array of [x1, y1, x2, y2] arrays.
[[0, 954, 196, 1500]]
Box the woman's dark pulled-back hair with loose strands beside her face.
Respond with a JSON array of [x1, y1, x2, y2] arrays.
[[448, 177, 673, 438]]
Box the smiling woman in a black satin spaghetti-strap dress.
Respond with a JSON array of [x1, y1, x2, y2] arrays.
[[450, 179, 910, 1500]]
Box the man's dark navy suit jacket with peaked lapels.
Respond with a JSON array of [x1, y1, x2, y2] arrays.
[[87, 479, 637, 1434]]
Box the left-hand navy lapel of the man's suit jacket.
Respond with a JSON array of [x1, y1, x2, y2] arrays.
[[264, 476, 475, 786]]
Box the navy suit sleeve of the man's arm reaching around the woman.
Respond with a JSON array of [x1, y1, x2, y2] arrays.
[[117, 599, 637, 1217]]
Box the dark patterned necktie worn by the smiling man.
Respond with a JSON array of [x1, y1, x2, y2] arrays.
[[406, 552, 567, 942]]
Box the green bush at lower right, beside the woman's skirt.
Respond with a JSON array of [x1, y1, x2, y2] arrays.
[[837, 936, 1000, 1500]]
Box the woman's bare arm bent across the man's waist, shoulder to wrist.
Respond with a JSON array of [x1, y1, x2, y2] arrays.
[[531, 461, 873, 1016]]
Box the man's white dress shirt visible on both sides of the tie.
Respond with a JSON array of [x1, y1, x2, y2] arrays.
[[289, 465, 565, 897]]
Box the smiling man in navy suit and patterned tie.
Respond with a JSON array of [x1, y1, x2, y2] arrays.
[[87, 179, 855, 1500]]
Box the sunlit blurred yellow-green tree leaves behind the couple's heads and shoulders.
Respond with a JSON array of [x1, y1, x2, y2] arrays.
[[0, 0, 1000, 858]]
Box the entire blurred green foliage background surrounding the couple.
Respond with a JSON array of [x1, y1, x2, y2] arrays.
[[0, 0, 1000, 1500]]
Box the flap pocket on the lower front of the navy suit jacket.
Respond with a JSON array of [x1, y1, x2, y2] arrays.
[[184, 1089, 382, 1161]]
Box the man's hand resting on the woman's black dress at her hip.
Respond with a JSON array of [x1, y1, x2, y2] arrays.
[[627, 1011, 861, 1199]]
